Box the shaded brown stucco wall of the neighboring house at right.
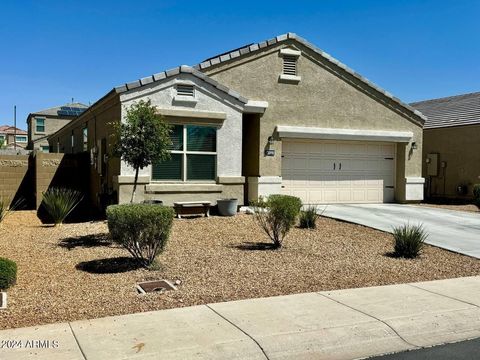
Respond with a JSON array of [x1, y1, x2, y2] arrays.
[[423, 125, 480, 197]]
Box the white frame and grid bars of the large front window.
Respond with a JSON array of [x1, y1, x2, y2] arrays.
[[151, 124, 218, 184]]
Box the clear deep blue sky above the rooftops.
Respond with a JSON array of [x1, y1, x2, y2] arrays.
[[0, 0, 480, 128]]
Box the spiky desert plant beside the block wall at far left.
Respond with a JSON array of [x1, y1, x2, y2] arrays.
[[42, 187, 83, 225]]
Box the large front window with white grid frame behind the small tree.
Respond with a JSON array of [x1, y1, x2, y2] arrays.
[[152, 125, 217, 181]]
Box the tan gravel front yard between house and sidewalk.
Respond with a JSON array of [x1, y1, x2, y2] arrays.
[[0, 211, 480, 328]]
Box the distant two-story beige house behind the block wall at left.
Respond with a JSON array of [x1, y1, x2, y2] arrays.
[[27, 103, 88, 152]]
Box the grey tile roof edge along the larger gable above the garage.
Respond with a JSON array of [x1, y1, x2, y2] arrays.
[[194, 33, 426, 122]]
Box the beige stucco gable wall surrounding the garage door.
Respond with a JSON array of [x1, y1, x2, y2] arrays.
[[204, 42, 422, 201]]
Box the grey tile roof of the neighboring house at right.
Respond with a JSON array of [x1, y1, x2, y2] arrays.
[[410, 92, 480, 129]]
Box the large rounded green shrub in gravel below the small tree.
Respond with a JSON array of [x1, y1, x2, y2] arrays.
[[107, 204, 175, 267]]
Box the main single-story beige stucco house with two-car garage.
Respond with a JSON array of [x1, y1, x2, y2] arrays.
[[48, 33, 425, 210]]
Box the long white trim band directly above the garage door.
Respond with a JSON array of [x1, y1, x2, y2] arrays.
[[276, 125, 413, 143]]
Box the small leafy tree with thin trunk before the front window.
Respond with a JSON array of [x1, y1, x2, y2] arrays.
[[115, 100, 172, 203]]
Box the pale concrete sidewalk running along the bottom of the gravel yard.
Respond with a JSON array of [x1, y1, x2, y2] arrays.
[[0, 276, 480, 360]]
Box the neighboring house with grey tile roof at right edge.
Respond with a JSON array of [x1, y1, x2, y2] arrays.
[[410, 92, 480, 198]]
